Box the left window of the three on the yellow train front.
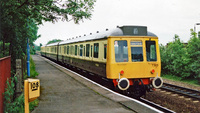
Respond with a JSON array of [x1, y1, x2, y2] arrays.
[[114, 40, 128, 62]]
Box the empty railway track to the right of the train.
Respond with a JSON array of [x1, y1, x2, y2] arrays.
[[161, 83, 200, 101]]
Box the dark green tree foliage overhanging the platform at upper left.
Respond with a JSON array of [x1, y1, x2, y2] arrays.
[[0, 0, 95, 70]]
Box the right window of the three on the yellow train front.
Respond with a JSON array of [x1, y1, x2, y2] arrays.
[[146, 41, 157, 61]]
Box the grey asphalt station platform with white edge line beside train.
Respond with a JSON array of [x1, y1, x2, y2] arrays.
[[32, 55, 161, 113]]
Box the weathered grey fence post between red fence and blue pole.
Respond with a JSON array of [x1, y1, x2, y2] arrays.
[[15, 59, 22, 97]]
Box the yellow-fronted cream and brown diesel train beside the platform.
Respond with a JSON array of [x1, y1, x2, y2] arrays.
[[41, 26, 163, 97]]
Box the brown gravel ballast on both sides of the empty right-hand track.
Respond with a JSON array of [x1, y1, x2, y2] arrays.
[[144, 79, 200, 113]]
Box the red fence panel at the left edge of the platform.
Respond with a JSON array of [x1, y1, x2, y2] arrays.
[[0, 56, 11, 113]]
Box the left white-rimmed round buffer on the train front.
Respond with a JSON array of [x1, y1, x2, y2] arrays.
[[118, 78, 130, 90]]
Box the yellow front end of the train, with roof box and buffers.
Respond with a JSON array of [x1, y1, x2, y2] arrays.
[[106, 26, 163, 97]]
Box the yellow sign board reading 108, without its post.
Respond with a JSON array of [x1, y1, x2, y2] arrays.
[[28, 79, 40, 100]]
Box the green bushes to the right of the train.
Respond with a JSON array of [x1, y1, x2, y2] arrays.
[[160, 30, 200, 79]]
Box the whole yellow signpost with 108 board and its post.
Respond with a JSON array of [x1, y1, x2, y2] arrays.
[[24, 79, 40, 113]]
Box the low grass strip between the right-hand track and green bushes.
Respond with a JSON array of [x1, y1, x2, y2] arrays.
[[162, 74, 200, 86]]
